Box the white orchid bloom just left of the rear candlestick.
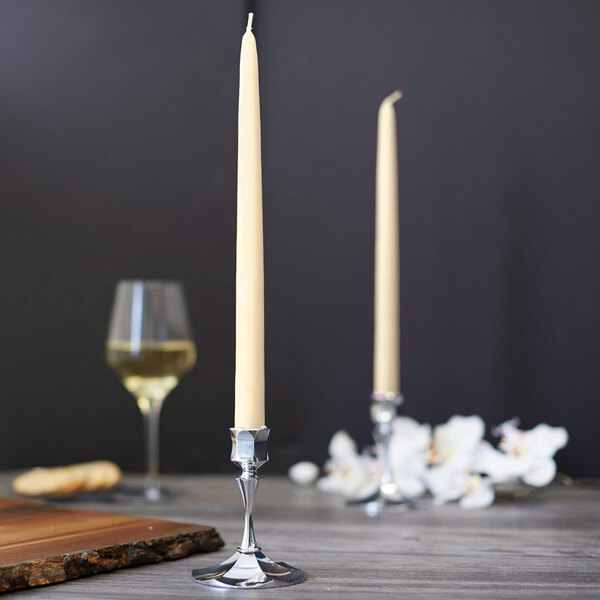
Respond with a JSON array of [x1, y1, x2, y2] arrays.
[[317, 431, 377, 498]]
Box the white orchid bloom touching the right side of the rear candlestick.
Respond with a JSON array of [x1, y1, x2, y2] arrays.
[[389, 417, 431, 498]]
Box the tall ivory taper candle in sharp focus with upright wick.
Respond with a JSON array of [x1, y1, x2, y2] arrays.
[[235, 13, 265, 429]]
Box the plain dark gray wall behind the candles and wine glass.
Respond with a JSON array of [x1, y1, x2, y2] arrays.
[[0, 0, 600, 476]]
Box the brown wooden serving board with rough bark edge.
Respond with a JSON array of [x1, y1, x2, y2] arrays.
[[0, 498, 223, 592]]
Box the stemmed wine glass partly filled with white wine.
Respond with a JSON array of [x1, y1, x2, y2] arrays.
[[106, 280, 196, 500]]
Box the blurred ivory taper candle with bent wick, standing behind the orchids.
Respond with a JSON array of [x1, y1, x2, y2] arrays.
[[373, 91, 402, 396]]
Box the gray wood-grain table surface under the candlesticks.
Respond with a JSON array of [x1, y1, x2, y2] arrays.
[[0, 469, 600, 600]]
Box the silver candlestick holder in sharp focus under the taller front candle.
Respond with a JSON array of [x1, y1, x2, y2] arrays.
[[192, 427, 306, 589]]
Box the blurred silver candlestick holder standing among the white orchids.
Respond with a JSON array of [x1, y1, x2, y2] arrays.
[[349, 393, 412, 505]]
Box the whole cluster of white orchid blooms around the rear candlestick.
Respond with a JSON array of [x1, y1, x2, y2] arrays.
[[317, 415, 569, 509]]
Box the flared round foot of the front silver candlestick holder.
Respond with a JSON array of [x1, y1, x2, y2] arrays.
[[192, 548, 306, 589]]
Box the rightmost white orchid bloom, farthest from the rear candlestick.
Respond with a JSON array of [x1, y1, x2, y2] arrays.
[[488, 420, 569, 487]]
